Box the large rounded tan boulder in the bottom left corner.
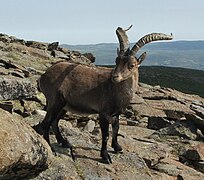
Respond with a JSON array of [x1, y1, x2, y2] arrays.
[[0, 109, 53, 179]]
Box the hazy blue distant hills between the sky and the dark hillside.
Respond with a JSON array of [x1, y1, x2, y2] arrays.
[[61, 41, 204, 70]]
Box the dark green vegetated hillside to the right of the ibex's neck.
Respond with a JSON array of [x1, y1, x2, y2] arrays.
[[139, 66, 204, 97]]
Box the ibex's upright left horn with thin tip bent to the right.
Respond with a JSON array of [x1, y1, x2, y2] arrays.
[[116, 25, 132, 54]]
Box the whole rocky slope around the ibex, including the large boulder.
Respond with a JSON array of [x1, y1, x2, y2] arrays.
[[0, 34, 204, 180]]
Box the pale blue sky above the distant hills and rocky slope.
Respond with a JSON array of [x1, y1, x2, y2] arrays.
[[0, 0, 204, 44]]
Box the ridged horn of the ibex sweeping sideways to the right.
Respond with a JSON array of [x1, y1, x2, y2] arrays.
[[130, 33, 173, 56]]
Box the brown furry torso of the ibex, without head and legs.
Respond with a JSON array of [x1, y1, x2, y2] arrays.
[[39, 62, 135, 115]]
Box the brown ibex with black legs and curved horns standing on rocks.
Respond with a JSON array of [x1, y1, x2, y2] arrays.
[[39, 26, 173, 163]]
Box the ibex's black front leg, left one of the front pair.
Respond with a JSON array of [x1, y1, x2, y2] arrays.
[[99, 115, 112, 164]]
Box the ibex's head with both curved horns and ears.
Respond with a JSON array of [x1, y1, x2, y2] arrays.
[[112, 25, 173, 83]]
